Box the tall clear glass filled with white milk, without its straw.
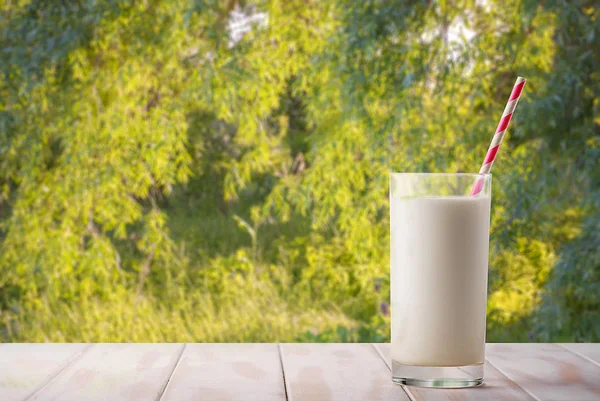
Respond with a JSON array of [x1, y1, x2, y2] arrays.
[[390, 173, 492, 388]]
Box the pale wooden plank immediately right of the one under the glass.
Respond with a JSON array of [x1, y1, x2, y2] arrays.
[[486, 344, 600, 401]]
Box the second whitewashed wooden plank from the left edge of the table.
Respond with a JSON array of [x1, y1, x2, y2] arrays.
[[32, 344, 184, 401]]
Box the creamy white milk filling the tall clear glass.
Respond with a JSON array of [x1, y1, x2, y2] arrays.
[[390, 196, 490, 366]]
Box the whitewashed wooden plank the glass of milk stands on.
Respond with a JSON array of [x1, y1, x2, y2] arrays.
[[374, 344, 535, 401]]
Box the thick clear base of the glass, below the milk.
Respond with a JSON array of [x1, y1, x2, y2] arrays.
[[392, 361, 483, 388]]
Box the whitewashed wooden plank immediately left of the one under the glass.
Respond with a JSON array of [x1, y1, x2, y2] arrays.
[[281, 344, 409, 401]]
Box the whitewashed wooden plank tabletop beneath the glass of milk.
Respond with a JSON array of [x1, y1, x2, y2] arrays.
[[0, 344, 600, 401]]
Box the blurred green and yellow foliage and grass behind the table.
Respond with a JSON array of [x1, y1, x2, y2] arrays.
[[0, 0, 600, 342]]
